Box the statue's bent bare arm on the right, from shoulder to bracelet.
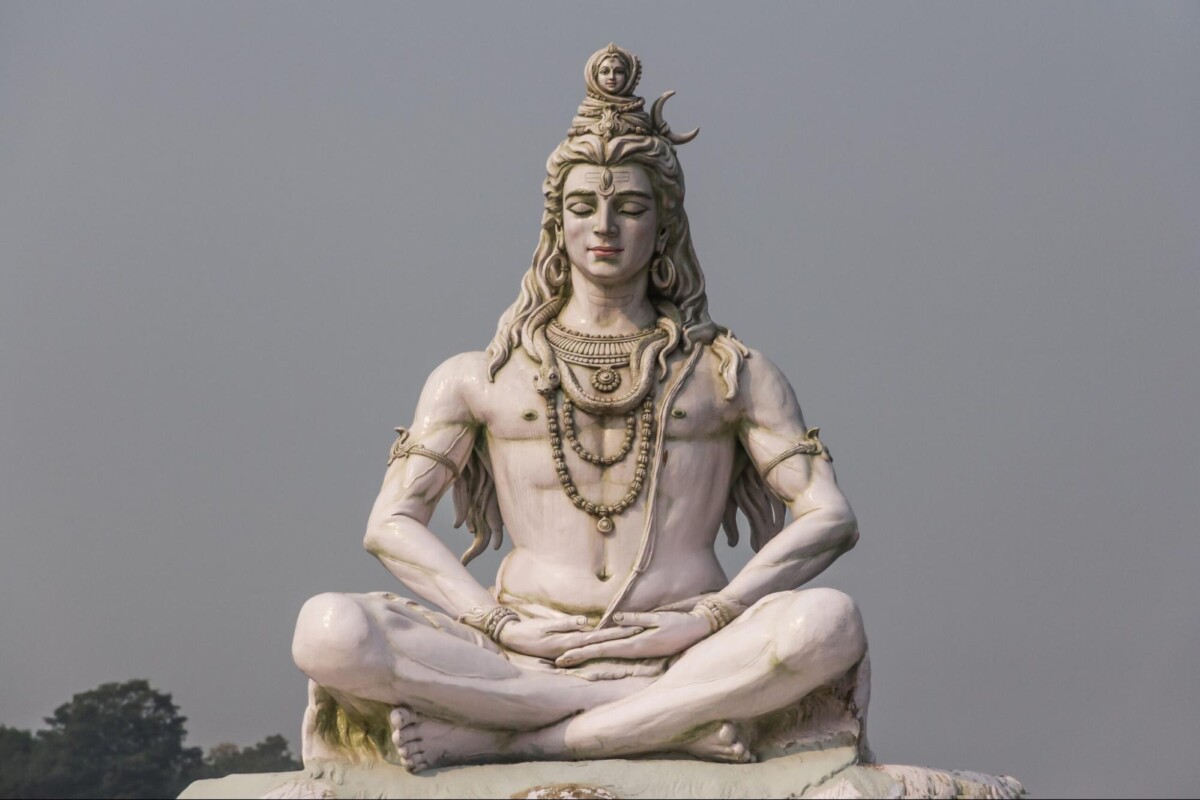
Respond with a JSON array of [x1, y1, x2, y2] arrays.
[[720, 353, 858, 606]]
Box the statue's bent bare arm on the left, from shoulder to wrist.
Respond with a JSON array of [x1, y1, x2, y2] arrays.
[[362, 353, 496, 616]]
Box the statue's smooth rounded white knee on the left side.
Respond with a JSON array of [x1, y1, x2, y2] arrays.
[[292, 593, 372, 684]]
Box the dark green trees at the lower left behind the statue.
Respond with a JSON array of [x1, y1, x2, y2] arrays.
[[0, 680, 301, 798]]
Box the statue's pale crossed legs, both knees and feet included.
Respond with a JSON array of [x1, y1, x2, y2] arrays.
[[293, 589, 866, 770]]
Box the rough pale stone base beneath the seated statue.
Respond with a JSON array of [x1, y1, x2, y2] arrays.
[[180, 746, 1024, 800]]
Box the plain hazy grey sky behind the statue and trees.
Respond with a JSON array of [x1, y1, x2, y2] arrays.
[[0, 2, 1200, 796]]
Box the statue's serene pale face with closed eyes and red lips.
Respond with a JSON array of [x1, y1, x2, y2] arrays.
[[563, 164, 659, 285]]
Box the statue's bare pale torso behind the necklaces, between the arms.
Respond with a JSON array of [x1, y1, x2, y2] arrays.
[[469, 350, 738, 614]]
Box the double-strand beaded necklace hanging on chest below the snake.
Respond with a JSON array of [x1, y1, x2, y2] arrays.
[[544, 386, 654, 534]]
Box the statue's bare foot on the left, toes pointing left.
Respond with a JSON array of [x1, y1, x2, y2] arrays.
[[388, 705, 504, 775]]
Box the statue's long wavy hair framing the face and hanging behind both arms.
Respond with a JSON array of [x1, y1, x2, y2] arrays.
[[454, 133, 784, 564]]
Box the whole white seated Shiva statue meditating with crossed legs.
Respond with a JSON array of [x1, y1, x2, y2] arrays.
[[293, 46, 868, 772]]
